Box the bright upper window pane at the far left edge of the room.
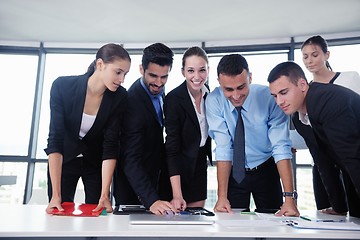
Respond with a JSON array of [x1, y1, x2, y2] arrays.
[[0, 54, 38, 156]]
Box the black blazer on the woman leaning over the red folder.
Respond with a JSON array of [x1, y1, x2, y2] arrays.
[[45, 70, 127, 166]]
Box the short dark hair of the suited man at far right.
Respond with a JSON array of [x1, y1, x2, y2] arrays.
[[268, 61, 306, 85]]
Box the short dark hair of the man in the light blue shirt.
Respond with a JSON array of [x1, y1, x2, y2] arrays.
[[217, 54, 249, 77]]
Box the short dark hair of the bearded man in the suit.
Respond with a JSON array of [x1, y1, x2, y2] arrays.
[[141, 43, 174, 71]]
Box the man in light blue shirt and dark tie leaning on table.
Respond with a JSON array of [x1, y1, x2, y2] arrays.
[[206, 54, 299, 216]]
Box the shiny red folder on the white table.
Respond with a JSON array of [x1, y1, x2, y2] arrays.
[[51, 202, 104, 217]]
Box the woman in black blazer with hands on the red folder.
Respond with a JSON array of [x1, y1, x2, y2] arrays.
[[45, 43, 131, 213]]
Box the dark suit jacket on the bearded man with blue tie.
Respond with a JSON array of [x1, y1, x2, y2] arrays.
[[115, 78, 169, 208]]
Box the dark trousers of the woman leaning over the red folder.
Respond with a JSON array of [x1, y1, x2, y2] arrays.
[[48, 157, 102, 204]]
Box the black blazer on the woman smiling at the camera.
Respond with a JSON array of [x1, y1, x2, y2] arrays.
[[164, 81, 212, 183]]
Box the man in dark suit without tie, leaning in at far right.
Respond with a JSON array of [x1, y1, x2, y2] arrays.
[[268, 62, 360, 217]]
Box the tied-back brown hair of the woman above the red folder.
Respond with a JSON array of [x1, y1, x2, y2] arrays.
[[88, 43, 131, 74]]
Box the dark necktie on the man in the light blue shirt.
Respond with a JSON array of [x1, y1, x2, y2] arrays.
[[233, 107, 245, 183]]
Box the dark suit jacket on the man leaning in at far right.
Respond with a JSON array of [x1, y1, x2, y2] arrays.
[[306, 82, 360, 204]]
